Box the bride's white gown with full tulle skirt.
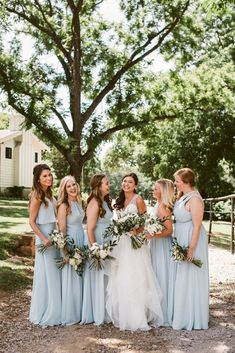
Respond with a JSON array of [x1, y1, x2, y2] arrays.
[[106, 195, 163, 331]]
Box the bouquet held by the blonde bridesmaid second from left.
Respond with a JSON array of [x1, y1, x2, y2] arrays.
[[55, 246, 89, 276]]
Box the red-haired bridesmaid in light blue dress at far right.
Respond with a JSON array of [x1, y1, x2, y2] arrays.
[[168, 168, 209, 330]]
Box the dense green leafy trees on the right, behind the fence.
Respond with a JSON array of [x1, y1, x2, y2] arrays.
[[102, 0, 235, 197]]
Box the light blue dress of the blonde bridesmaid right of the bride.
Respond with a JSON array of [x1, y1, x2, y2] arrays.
[[150, 204, 172, 326]]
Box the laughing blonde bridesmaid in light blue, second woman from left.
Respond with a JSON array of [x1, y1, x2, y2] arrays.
[[57, 175, 84, 325]]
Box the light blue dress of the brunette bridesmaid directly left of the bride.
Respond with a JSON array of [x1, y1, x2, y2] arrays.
[[81, 201, 113, 325]]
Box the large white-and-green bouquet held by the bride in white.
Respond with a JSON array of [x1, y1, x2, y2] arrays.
[[104, 212, 146, 249]]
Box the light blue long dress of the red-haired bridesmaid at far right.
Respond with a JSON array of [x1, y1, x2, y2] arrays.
[[168, 191, 209, 330]]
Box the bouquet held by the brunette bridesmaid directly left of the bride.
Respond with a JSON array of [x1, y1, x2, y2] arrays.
[[88, 242, 116, 270]]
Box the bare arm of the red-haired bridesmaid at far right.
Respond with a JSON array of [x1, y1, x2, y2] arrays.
[[187, 197, 204, 261]]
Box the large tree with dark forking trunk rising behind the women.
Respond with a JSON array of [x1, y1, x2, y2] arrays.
[[0, 0, 193, 180]]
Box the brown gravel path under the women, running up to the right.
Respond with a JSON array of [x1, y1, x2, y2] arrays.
[[0, 246, 235, 353]]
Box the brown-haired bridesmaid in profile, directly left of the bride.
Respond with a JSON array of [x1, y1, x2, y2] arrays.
[[82, 174, 112, 325]]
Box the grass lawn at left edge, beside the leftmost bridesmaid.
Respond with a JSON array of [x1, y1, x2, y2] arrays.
[[0, 200, 33, 292]]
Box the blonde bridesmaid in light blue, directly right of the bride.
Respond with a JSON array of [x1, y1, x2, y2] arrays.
[[145, 179, 174, 326]]
